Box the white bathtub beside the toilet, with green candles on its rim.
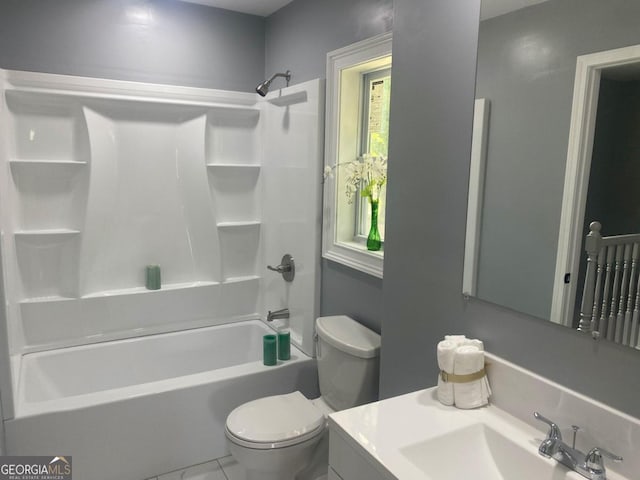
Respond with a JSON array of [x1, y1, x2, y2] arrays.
[[5, 320, 317, 480]]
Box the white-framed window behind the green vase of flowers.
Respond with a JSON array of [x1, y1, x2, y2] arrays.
[[322, 34, 391, 277]]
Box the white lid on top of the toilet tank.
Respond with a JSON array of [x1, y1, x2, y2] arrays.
[[316, 315, 380, 358]]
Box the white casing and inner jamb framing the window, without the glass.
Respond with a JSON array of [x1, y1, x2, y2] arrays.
[[322, 33, 392, 278]]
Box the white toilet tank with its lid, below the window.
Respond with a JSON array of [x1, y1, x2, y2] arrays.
[[316, 315, 380, 410]]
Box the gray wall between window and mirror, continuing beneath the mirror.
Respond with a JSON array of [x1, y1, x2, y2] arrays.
[[381, 0, 640, 417]]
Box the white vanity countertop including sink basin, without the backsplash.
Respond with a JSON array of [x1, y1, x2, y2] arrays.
[[330, 390, 584, 480]]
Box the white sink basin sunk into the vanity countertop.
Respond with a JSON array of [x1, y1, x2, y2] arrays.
[[400, 423, 554, 480]]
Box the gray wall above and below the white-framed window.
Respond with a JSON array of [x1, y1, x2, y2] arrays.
[[265, 0, 393, 332]]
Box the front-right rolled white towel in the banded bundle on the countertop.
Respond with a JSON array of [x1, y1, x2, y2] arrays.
[[453, 345, 489, 408]]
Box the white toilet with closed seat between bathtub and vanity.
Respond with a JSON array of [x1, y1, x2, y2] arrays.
[[225, 315, 380, 480]]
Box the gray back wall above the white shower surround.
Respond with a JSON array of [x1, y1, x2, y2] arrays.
[[0, 0, 264, 92]]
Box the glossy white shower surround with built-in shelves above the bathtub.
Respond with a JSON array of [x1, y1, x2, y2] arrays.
[[0, 71, 324, 418]]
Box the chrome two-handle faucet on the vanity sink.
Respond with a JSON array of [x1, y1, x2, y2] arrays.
[[533, 412, 622, 480]]
